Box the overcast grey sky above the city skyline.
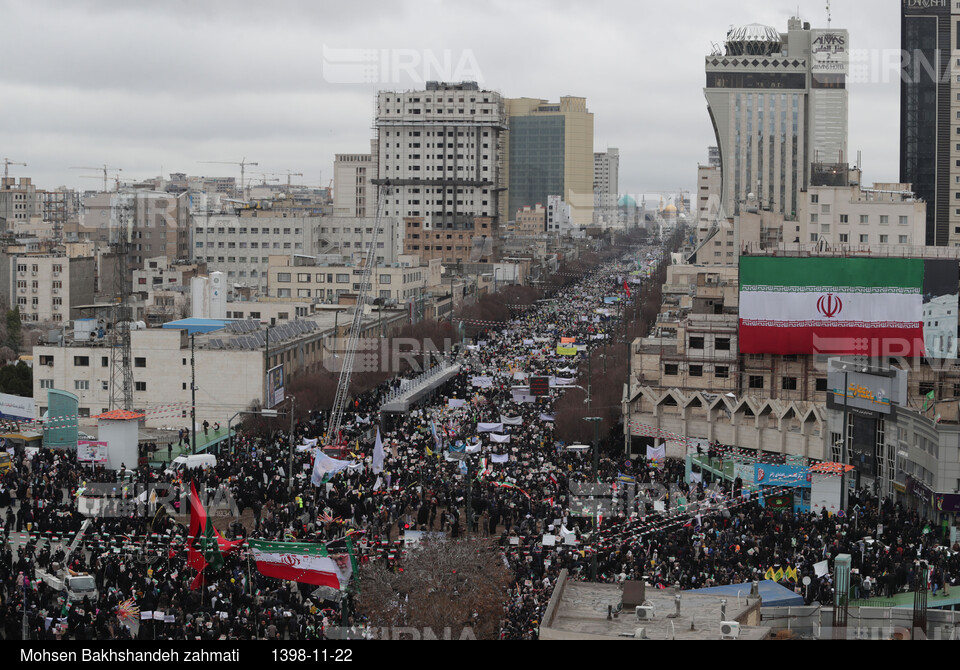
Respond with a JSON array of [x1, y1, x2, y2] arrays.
[[0, 0, 900, 198]]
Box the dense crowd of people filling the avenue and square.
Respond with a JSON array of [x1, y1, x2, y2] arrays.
[[0, 249, 960, 640]]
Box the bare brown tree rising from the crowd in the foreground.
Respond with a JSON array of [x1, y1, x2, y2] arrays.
[[356, 540, 511, 640]]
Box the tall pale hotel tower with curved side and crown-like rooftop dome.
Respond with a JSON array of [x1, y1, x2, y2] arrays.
[[704, 18, 849, 220]]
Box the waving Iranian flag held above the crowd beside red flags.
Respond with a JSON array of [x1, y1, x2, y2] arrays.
[[248, 540, 353, 589]]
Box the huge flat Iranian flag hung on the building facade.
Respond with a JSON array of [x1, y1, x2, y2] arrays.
[[740, 257, 924, 357]]
